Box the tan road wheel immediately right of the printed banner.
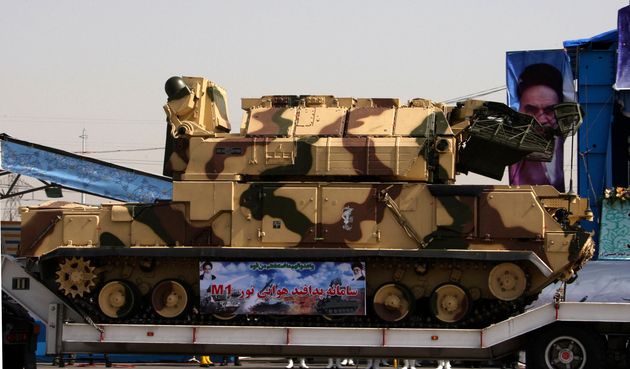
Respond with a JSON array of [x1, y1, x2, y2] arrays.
[[373, 283, 413, 322]]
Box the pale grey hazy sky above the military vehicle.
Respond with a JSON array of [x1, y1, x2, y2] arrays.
[[0, 0, 628, 207]]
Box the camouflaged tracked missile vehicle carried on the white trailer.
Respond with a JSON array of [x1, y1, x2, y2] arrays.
[[19, 77, 593, 327]]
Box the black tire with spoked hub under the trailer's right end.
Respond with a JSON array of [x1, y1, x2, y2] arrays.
[[527, 324, 606, 369]]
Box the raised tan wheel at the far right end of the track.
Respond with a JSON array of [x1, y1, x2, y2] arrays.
[[488, 263, 527, 301]]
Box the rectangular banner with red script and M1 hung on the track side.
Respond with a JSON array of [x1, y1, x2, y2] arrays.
[[199, 260, 365, 315]]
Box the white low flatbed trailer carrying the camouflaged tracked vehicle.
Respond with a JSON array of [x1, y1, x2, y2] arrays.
[[2, 256, 630, 368]]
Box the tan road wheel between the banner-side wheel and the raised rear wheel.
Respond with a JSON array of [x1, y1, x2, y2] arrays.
[[431, 284, 470, 323]]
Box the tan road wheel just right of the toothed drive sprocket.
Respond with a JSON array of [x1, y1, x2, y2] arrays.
[[98, 281, 139, 318]]
